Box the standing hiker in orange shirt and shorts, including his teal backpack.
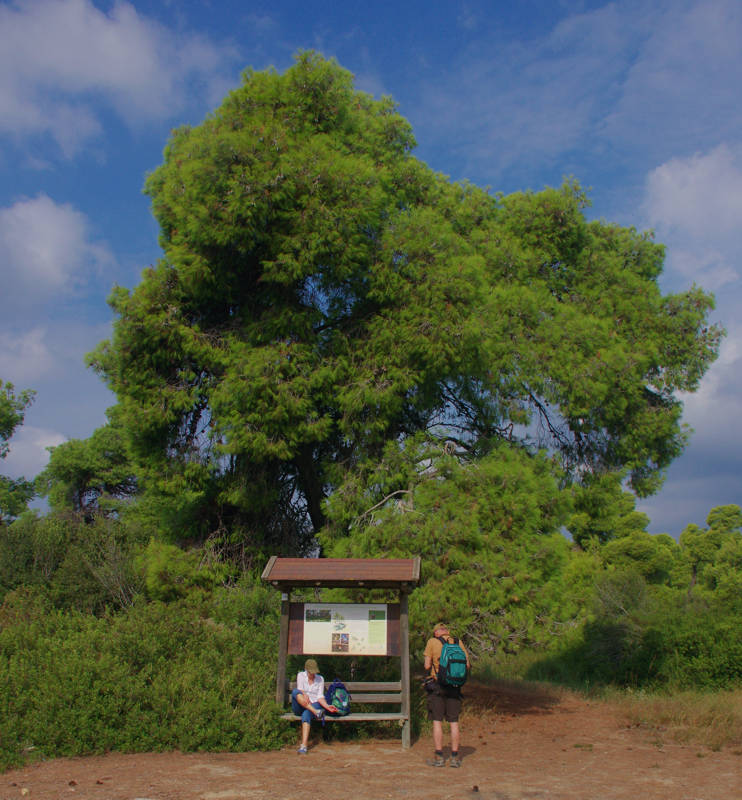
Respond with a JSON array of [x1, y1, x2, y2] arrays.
[[424, 622, 469, 767]]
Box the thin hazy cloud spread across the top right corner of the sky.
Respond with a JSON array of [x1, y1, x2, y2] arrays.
[[406, 0, 742, 188]]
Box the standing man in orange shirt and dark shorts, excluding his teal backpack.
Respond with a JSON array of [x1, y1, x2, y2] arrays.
[[425, 622, 469, 767]]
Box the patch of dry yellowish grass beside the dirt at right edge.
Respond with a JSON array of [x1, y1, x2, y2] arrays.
[[606, 689, 742, 753]]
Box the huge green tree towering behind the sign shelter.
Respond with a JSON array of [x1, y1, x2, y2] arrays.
[[90, 53, 721, 552]]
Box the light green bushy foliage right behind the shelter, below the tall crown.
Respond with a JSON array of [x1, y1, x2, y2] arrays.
[[321, 443, 574, 656]]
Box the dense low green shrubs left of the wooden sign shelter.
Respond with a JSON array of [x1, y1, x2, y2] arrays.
[[0, 583, 294, 768]]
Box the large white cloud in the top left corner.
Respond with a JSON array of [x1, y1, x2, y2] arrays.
[[0, 0, 235, 156]]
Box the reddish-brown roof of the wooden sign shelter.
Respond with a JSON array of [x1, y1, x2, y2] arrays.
[[261, 556, 420, 589]]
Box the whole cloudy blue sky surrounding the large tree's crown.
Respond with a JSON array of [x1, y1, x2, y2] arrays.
[[0, 0, 742, 536]]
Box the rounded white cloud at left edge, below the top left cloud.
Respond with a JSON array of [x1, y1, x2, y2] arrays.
[[0, 194, 112, 310]]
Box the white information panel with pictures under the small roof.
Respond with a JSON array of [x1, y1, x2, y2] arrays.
[[303, 603, 388, 656]]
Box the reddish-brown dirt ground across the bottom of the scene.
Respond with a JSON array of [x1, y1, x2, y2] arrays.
[[0, 685, 742, 800]]
